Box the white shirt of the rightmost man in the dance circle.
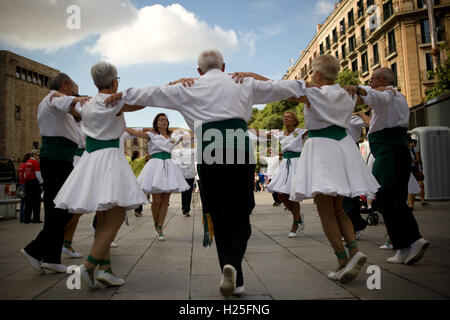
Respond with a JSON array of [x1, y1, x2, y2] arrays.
[[361, 86, 409, 134]]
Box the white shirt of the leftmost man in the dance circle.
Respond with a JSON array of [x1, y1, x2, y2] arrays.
[[37, 90, 79, 144]]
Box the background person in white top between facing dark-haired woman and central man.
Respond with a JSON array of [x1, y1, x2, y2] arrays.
[[172, 135, 197, 217]]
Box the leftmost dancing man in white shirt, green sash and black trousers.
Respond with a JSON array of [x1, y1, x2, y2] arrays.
[[20, 73, 89, 273]]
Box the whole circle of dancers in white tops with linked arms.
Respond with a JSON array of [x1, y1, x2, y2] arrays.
[[21, 50, 430, 297]]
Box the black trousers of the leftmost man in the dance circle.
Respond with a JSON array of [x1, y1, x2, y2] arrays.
[[25, 158, 73, 264]]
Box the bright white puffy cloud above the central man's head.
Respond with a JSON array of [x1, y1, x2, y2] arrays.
[[88, 4, 239, 65]]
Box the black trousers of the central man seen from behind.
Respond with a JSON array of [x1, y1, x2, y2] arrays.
[[199, 164, 255, 286]]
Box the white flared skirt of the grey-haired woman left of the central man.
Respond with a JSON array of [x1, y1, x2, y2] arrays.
[[54, 148, 148, 213]]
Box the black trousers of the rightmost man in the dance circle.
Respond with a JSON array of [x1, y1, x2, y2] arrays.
[[374, 147, 421, 250]]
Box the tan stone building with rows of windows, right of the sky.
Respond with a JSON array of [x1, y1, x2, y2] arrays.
[[284, 0, 450, 106]]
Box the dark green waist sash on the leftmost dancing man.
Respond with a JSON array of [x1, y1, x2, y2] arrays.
[[39, 136, 78, 162]]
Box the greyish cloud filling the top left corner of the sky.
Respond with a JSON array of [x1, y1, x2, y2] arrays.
[[0, 0, 137, 51]]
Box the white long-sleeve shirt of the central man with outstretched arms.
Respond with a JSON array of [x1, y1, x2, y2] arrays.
[[122, 69, 306, 130]]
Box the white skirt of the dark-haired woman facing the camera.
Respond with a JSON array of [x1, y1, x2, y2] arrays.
[[137, 158, 190, 194]]
